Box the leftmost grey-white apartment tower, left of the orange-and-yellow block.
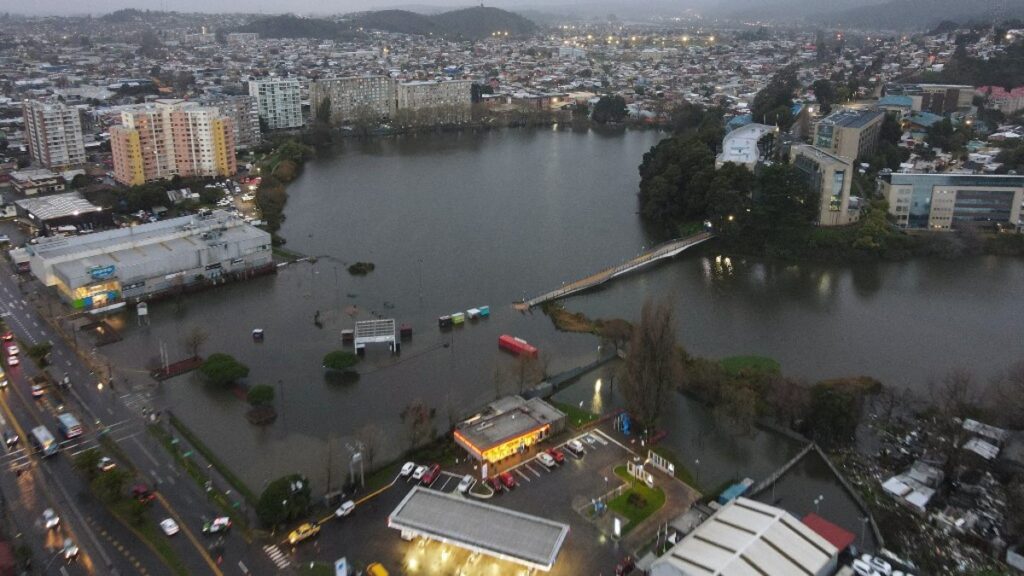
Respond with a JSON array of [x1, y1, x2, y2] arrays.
[[22, 100, 85, 168]]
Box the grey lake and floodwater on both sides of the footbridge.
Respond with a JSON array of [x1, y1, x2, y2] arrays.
[[103, 129, 1024, 510]]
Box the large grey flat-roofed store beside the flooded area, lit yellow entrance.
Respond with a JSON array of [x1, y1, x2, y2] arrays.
[[25, 210, 274, 312]]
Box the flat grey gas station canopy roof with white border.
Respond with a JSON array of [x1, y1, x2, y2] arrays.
[[388, 486, 569, 570]]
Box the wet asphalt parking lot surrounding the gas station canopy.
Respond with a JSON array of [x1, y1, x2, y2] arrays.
[[296, 424, 643, 576]]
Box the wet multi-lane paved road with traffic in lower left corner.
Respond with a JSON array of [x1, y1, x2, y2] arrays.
[[0, 263, 274, 576]]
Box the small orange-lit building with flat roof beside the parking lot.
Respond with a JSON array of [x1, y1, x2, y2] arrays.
[[455, 396, 565, 462]]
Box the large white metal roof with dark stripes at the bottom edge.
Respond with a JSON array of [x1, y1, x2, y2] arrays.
[[650, 498, 839, 576]]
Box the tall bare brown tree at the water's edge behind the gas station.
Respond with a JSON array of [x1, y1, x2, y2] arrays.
[[622, 299, 682, 429]]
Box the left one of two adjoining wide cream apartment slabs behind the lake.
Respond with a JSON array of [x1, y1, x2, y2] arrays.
[[309, 76, 395, 124]]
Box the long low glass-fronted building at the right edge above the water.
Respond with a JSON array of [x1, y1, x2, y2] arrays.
[[879, 173, 1024, 231]]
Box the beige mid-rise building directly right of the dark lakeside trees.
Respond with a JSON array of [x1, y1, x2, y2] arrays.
[[790, 145, 860, 227]]
